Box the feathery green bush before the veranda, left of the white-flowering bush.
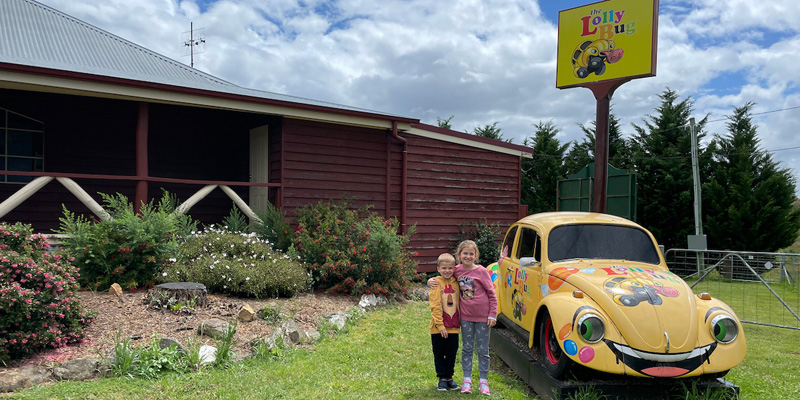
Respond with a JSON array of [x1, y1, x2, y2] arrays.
[[56, 192, 197, 290]]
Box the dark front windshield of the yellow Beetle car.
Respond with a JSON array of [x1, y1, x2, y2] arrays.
[[547, 224, 660, 264]]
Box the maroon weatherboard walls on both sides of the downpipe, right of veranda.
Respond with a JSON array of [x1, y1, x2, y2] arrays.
[[278, 119, 520, 271]]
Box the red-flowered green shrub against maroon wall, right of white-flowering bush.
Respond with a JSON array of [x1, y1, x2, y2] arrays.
[[295, 201, 417, 295]]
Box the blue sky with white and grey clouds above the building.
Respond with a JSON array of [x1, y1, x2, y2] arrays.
[[39, 0, 800, 183]]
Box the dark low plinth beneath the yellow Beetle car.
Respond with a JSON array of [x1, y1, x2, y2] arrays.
[[489, 316, 739, 400]]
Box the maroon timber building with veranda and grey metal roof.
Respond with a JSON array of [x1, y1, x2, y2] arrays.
[[0, 0, 532, 269]]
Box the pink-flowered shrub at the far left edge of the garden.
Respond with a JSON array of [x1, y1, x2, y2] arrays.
[[0, 223, 92, 361]]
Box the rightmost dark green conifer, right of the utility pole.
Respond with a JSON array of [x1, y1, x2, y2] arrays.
[[703, 102, 800, 252]]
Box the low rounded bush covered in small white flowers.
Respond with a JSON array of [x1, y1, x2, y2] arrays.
[[158, 226, 309, 298]]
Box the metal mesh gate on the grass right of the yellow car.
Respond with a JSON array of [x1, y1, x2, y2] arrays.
[[664, 249, 800, 330]]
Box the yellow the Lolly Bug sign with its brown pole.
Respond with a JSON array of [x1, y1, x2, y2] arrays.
[[556, 0, 658, 212]]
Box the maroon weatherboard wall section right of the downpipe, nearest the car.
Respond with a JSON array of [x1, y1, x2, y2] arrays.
[[406, 135, 520, 271]]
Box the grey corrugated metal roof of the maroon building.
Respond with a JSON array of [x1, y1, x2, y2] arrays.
[[0, 0, 406, 118]]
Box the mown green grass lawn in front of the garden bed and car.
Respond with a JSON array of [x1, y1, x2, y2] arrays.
[[13, 302, 800, 400]]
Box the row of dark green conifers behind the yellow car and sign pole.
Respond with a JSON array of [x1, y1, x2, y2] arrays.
[[444, 88, 800, 252]]
